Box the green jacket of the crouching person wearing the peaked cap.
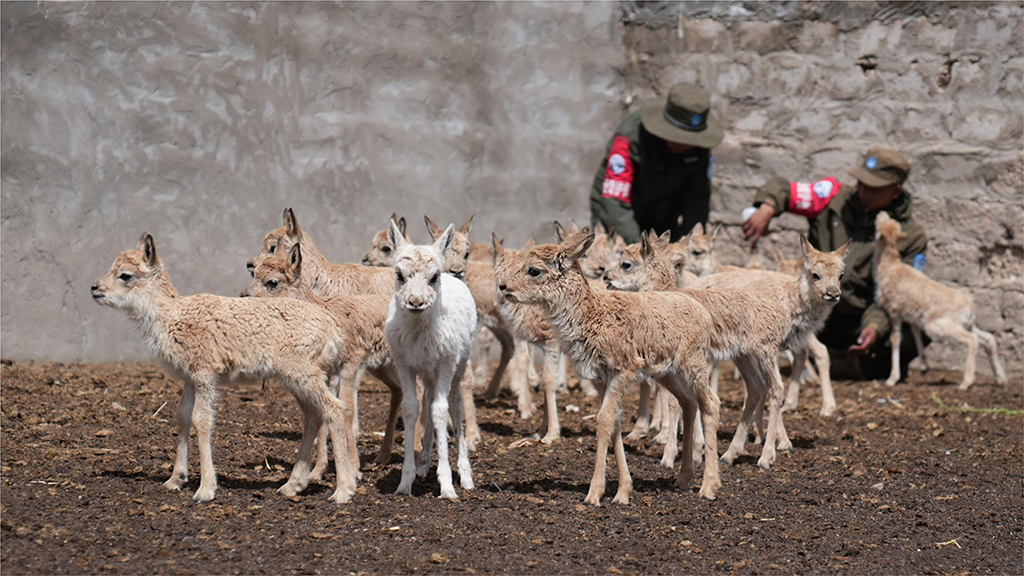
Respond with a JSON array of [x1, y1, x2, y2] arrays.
[[754, 176, 928, 340]]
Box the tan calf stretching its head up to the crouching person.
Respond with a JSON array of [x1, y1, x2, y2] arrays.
[[874, 211, 1007, 390]]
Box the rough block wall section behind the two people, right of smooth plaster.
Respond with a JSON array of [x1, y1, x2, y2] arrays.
[[621, 2, 1024, 377]]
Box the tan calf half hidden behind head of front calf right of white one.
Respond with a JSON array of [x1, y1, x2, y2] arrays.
[[490, 234, 561, 444]]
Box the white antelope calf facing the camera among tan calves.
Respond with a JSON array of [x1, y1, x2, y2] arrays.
[[384, 221, 476, 499]]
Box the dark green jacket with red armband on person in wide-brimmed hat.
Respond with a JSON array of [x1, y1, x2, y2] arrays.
[[590, 111, 715, 244]]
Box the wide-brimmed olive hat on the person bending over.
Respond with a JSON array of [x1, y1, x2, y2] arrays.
[[640, 82, 724, 148]]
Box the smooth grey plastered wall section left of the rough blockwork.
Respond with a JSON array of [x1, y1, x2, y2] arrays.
[[0, 2, 623, 361]]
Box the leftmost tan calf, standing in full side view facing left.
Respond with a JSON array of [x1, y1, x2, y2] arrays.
[[91, 234, 355, 503]]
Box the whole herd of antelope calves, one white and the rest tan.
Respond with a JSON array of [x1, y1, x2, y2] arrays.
[[91, 204, 1006, 506]]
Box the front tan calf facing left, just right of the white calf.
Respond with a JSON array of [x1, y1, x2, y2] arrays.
[[496, 229, 722, 506]]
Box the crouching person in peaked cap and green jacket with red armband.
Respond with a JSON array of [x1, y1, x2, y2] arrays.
[[743, 148, 928, 378]]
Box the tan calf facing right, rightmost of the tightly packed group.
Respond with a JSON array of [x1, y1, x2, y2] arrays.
[[693, 236, 850, 462]]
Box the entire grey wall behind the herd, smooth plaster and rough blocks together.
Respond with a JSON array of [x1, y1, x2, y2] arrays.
[[0, 2, 1024, 373]]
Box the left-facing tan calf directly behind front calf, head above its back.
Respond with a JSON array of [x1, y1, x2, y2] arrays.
[[604, 232, 790, 468]]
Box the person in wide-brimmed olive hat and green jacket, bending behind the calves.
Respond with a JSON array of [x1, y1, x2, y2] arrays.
[[590, 82, 723, 244]]
